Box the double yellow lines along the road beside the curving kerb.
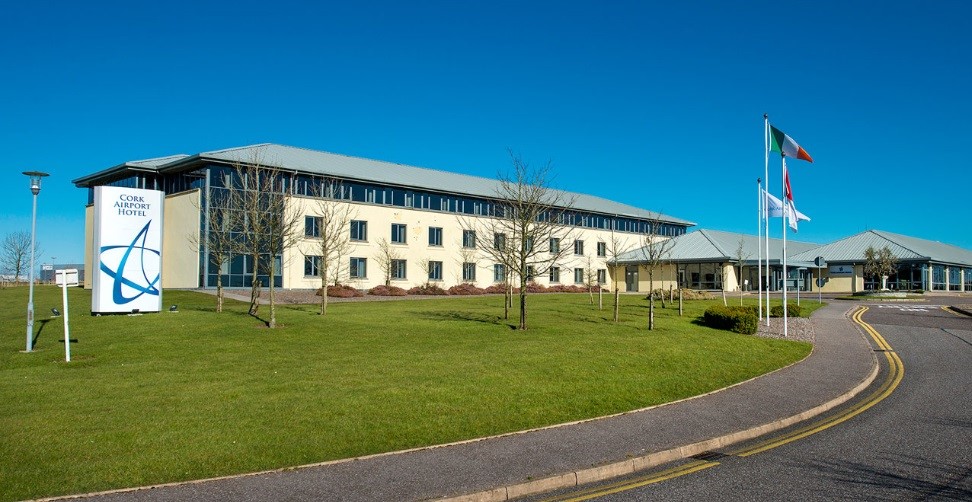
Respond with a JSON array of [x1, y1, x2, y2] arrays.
[[546, 307, 904, 502]]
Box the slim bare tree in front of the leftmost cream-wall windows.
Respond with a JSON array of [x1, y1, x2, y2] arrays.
[[305, 182, 355, 315]]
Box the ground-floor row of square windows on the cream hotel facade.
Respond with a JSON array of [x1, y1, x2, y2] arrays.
[[304, 256, 607, 284]]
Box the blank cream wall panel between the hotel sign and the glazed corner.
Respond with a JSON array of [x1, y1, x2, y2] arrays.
[[162, 190, 200, 288]]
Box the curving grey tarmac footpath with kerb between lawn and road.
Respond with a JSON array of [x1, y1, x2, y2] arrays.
[[76, 301, 878, 501]]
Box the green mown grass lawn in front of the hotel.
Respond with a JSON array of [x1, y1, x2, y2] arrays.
[[0, 286, 815, 500]]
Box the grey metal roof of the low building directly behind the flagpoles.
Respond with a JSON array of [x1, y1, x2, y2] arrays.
[[619, 229, 818, 264]]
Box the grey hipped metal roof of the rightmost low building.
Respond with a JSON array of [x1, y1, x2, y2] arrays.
[[796, 230, 972, 266]]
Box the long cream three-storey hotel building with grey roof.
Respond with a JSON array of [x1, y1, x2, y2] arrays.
[[74, 144, 694, 289]]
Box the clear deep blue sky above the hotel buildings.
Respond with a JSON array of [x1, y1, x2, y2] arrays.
[[0, 1, 972, 263]]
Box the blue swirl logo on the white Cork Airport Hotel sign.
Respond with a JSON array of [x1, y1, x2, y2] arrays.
[[100, 221, 162, 305]]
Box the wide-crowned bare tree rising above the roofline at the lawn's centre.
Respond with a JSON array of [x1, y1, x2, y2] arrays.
[[468, 151, 576, 329]]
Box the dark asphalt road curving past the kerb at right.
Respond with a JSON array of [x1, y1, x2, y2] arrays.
[[537, 299, 972, 501]]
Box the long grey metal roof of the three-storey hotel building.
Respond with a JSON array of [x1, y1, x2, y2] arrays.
[[74, 143, 695, 226]]
